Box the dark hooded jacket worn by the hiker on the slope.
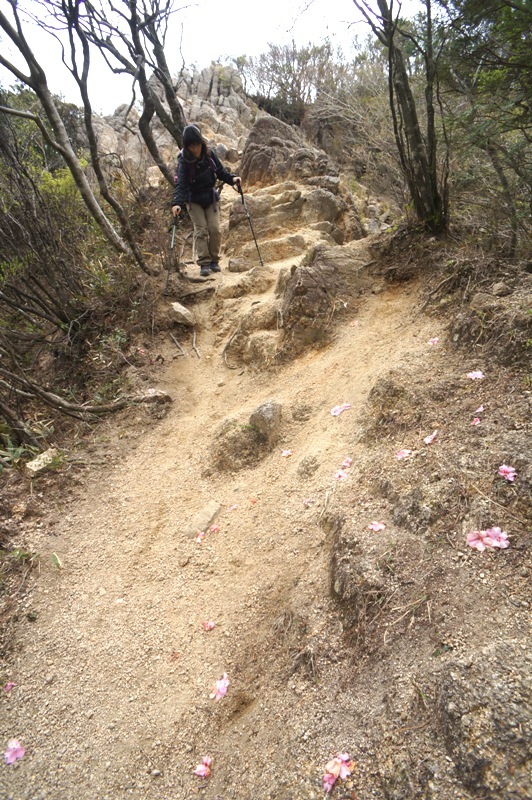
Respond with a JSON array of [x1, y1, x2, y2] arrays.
[[172, 147, 235, 208]]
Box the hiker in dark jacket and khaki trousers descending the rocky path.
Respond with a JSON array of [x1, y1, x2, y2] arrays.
[[172, 125, 242, 277]]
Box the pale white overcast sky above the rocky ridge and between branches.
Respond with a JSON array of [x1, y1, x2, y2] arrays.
[[0, 0, 419, 114]]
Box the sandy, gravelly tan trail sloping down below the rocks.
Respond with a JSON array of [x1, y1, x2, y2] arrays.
[[0, 242, 435, 800]]
